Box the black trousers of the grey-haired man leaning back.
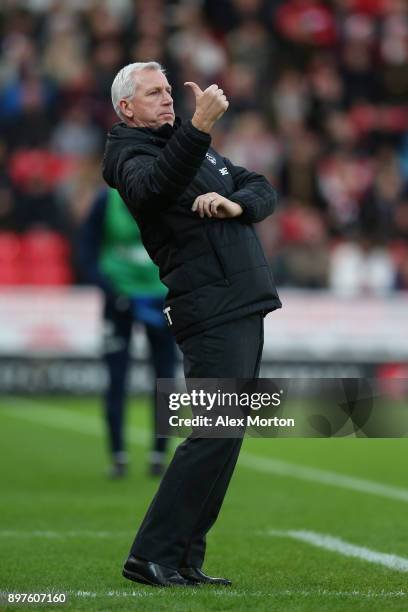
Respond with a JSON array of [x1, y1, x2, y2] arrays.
[[131, 314, 263, 568]]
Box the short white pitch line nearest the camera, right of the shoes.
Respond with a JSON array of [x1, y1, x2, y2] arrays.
[[267, 529, 408, 572]]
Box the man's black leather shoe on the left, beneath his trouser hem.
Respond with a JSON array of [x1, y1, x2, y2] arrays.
[[122, 555, 196, 586]]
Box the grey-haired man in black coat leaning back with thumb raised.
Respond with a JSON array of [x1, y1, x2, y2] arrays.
[[103, 62, 281, 586]]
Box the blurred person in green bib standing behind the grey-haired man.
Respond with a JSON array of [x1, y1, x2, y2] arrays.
[[79, 188, 176, 478]]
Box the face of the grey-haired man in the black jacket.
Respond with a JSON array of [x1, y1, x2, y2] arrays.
[[120, 70, 175, 129]]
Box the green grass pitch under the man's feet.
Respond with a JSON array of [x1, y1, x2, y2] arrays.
[[0, 397, 408, 612]]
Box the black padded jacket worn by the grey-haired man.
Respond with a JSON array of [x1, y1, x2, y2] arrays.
[[103, 119, 281, 343]]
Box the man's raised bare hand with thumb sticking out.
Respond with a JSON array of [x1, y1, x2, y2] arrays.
[[184, 81, 229, 133]]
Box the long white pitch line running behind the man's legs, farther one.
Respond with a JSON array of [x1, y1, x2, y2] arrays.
[[3, 398, 408, 503]]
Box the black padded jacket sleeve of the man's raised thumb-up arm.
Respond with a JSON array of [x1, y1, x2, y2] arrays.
[[116, 121, 211, 210]]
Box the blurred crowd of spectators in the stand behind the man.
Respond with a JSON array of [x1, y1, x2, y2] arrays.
[[0, 0, 408, 295]]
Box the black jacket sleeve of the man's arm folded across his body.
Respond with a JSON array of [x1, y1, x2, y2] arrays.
[[223, 157, 278, 223]]
